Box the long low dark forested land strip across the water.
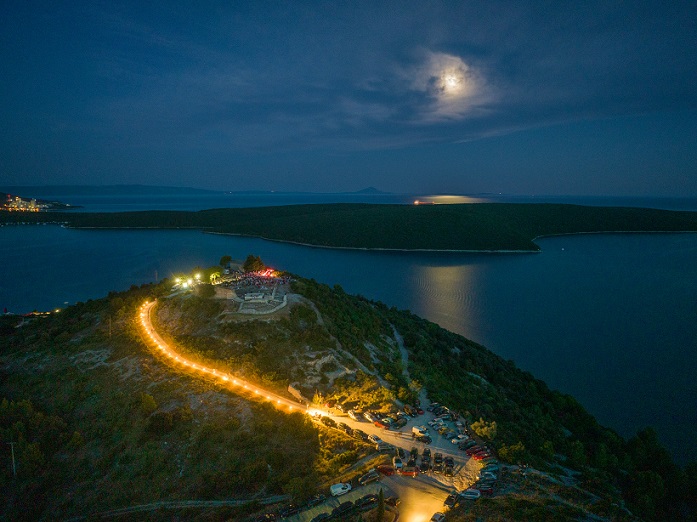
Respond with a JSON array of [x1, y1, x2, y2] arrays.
[[0, 203, 697, 252]]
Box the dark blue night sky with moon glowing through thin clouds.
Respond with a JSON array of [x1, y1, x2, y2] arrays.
[[0, 0, 697, 196]]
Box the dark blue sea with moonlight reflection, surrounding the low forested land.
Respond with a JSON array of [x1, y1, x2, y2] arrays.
[[0, 193, 697, 463]]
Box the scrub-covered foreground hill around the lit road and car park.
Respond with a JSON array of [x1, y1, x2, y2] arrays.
[[0, 266, 695, 520]]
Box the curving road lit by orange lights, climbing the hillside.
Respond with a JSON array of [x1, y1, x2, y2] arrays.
[[139, 301, 307, 413]]
